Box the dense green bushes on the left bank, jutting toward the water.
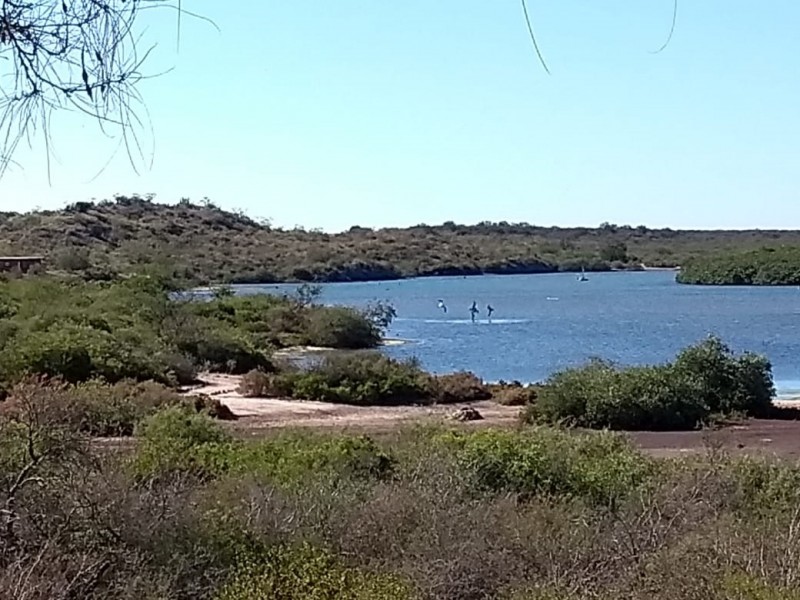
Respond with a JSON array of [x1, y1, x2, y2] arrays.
[[0, 276, 388, 388]]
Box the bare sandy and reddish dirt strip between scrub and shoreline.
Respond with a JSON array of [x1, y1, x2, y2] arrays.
[[187, 374, 800, 458]]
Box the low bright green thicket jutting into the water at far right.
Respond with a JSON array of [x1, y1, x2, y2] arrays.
[[678, 246, 800, 285]]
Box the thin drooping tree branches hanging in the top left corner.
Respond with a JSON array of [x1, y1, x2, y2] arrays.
[[0, 0, 198, 176]]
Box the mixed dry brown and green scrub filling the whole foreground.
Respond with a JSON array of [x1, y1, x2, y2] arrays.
[[0, 386, 800, 600]]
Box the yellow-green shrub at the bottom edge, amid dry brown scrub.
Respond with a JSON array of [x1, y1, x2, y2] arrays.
[[216, 545, 414, 600]]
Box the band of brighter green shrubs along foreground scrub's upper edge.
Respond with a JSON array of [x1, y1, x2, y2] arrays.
[[128, 408, 654, 505]]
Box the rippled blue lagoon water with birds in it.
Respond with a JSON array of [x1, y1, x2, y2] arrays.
[[230, 272, 800, 395]]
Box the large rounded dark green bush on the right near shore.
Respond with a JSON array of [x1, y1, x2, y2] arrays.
[[526, 338, 775, 430]]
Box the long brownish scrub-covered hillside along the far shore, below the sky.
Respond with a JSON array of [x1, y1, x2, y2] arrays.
[[0, 196, 800, 283]]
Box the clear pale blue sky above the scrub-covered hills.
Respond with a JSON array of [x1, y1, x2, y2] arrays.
[[0, 0, 800, 231]]
